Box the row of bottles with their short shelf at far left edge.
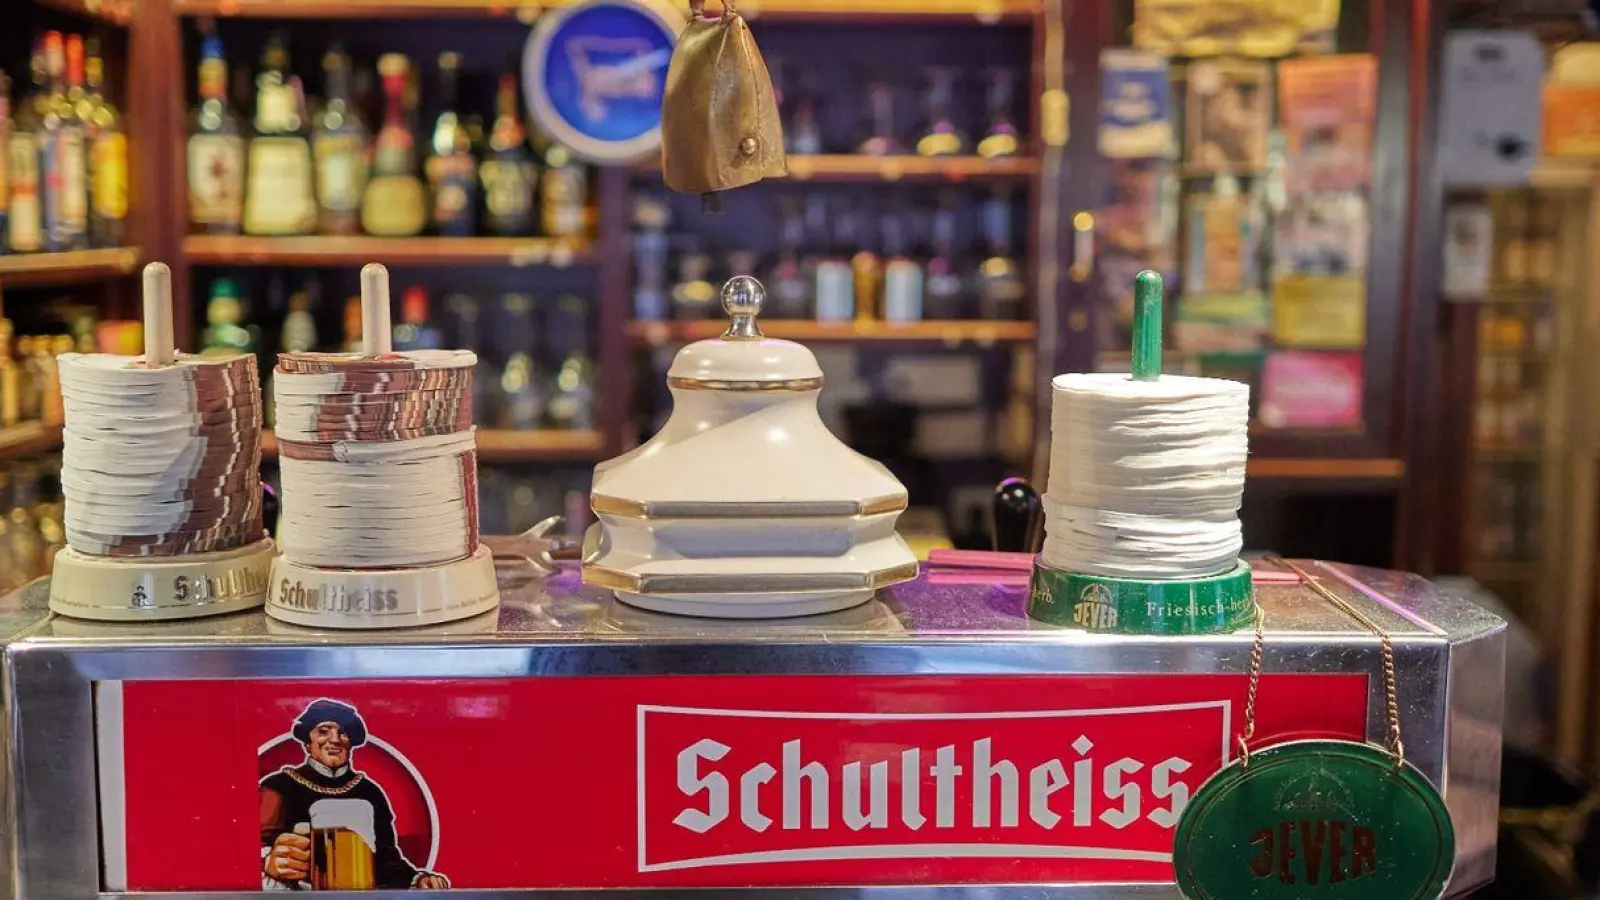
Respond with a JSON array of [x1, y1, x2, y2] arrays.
[[0, 30, 139, 277]]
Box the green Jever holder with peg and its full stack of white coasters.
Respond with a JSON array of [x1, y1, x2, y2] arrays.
[[1029, 271, 1254, 634]]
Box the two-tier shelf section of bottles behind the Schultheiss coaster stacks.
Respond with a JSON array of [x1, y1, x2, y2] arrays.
[[182, 21, 610, 463]]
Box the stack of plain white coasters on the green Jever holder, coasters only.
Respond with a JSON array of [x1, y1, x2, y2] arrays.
[[1042, 373, 1250, 580]]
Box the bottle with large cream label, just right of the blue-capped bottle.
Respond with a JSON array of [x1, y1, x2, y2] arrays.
[[243, 34, 317, 235]]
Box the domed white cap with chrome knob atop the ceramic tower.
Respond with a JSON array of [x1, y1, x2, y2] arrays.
[[667, 275, 822, 391]]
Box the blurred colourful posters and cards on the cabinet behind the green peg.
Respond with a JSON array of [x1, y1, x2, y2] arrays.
[[1094, 0, 1378, 432]]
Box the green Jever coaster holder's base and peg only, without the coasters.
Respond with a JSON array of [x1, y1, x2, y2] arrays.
[[1027, 269, 1254, 634]]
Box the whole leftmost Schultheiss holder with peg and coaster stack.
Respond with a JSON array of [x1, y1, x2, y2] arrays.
[[50, 263, 272, 621]]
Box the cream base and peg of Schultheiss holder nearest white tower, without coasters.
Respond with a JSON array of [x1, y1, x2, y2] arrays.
[[267, 263, 499, 629]]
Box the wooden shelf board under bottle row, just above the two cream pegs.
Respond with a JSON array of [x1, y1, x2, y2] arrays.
[[184, 234, 590, 267]]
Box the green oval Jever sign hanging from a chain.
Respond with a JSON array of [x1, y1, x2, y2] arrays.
[[1173, 740, 1456, 900]]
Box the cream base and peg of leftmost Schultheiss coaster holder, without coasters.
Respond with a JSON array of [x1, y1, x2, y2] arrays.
[[50, 263, 272, 621]]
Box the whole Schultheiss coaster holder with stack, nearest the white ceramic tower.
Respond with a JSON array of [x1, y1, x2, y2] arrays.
[[267, 264, 499, 628]]
